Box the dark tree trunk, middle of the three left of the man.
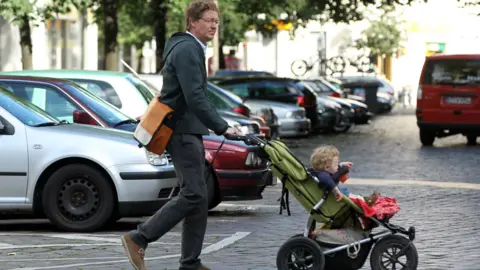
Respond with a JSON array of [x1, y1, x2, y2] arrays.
[[102, 0, 118, 71]]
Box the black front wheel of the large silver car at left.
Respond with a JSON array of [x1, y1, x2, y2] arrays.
[[42, 164, 115, 232]]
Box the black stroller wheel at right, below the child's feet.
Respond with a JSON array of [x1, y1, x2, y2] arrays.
[[370, 235, 418, 270]]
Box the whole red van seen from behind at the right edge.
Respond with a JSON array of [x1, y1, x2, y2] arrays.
[[416, 54, 480, 146]]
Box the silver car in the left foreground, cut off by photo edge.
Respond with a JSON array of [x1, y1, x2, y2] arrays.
[[0, 89, 178, 231]]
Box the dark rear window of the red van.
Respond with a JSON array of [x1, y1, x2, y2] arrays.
[[423, 59, 480, 86]]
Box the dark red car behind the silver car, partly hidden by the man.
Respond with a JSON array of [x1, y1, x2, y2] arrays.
[[0, 76, 272, 209]]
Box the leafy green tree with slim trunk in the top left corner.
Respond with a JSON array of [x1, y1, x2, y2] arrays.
[[0, 0, 89, 69]]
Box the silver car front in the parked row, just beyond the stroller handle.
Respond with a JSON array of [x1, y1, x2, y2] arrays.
[[243, 100, 311, 137]]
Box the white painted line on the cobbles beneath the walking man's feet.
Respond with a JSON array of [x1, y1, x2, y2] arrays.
[[8, 232, 250, 270]]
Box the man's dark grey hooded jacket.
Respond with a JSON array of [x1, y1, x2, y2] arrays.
[[160, 32, 228, 135]]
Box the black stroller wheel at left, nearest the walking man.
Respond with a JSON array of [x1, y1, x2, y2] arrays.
[[277, 235, 325, 270]]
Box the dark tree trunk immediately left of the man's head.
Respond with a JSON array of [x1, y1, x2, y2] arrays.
[[151, 0, 168, 73]]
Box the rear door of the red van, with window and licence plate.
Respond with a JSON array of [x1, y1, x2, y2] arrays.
[[418, 56, 480, 124]]
